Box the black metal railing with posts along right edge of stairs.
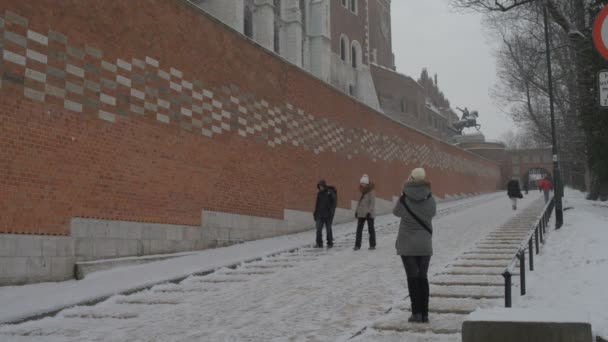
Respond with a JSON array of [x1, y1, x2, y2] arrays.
[[502, 197, 555, 308]]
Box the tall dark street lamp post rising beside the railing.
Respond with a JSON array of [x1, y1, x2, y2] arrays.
[[543, 3, 564, 229]]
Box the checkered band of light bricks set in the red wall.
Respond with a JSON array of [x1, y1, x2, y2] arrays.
[[0, 11, 498, 177]]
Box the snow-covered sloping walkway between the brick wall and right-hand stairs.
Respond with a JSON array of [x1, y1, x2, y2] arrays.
[[0, 193, 540, 341]]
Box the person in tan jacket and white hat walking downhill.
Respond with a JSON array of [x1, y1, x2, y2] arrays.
[[355, 175, 376, 250]]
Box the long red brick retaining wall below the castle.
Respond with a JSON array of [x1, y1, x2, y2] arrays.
[[0, 0, 500, 234]]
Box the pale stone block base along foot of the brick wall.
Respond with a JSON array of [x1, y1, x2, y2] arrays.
[[0, 197, 404, 286]]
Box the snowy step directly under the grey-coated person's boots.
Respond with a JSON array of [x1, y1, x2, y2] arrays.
[[372, 312, 466, 334]]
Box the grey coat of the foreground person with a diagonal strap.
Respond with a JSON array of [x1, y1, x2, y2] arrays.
[[393, 180, 437, 256]]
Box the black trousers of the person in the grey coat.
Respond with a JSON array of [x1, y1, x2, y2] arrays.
[[401, 255, 431, 316]]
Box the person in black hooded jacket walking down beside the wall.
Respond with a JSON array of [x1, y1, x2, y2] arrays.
[[313, 180, 338, 248]]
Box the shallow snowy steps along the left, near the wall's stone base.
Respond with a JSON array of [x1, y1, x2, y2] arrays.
[[0, 223, 399, 341]]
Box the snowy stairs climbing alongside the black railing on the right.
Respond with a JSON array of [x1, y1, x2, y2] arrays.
[[360, 199, 544, 341]]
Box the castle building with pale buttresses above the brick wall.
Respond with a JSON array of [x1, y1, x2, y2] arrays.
[[191, 0, 457, 141]]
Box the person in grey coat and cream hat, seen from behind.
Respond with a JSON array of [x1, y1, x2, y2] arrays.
[[393, 168, 437, 323]]
